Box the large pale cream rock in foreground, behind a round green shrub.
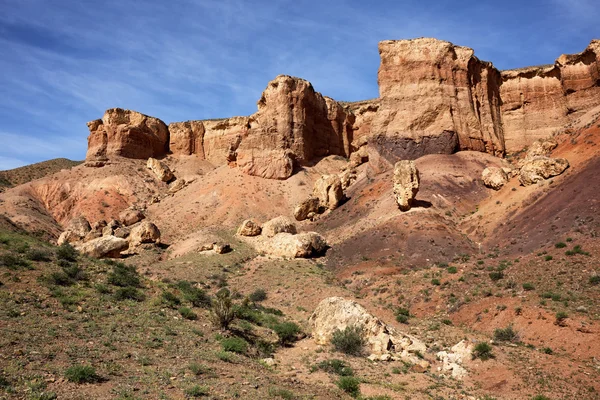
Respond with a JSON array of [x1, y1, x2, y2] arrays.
[[308, 297, 427, 363]]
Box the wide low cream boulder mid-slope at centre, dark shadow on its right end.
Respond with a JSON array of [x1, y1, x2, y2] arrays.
[[262, 232, 327, 258]]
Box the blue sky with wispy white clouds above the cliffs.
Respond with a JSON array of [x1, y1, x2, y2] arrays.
[[0, 0, 600, 169]]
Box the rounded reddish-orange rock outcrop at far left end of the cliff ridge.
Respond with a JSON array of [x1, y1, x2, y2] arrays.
[[86, 108, 169, 161]]
